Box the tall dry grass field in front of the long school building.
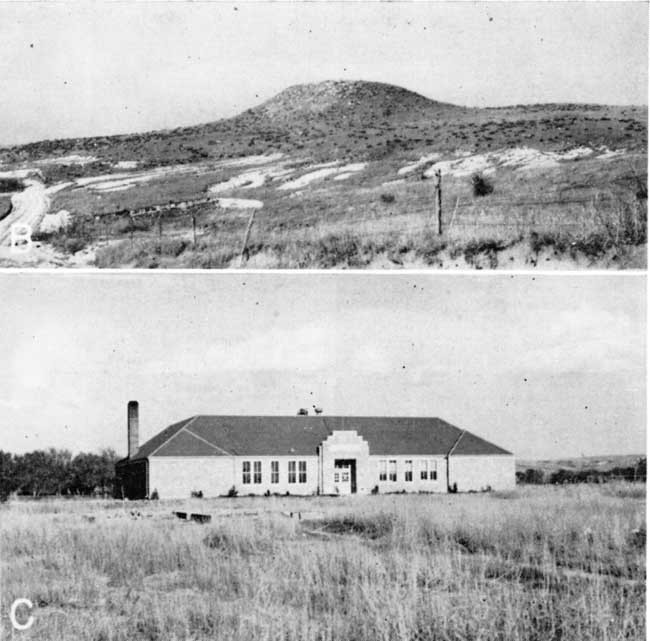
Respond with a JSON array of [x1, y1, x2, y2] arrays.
[[0, 483, 645, 641]]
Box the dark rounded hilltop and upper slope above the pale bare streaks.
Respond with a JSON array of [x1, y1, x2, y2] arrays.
[[0, 81, 648, 170]]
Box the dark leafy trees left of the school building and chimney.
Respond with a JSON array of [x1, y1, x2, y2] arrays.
[[0, 447, 118, 501]]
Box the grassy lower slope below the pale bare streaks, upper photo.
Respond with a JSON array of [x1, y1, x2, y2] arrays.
[[36, 154, 647, 268]]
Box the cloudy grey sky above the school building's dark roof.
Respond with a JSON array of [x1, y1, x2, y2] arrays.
[[0, 273, 646, 458]]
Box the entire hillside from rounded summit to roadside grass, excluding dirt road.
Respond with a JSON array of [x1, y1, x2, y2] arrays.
[[0, 81, 647, 268]]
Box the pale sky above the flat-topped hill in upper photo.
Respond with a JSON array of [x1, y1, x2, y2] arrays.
[[0, 2, 648, 145]]
